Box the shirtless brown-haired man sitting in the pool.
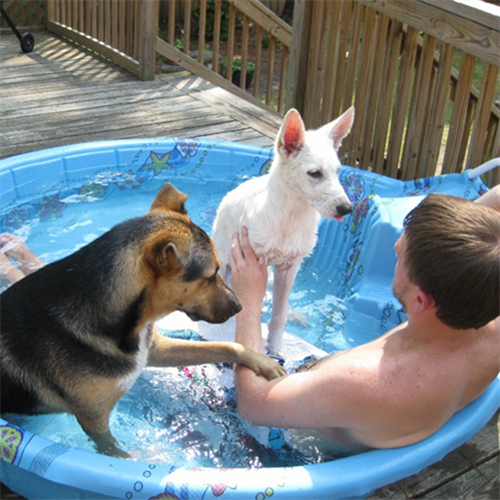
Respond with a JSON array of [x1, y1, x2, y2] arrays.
[[231, 186, 500, 450]]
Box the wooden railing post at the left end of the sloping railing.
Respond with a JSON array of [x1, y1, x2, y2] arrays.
[[139, 0, 159, 80]]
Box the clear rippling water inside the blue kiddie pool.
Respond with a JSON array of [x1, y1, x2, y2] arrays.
[[0, 173, 368, 467]]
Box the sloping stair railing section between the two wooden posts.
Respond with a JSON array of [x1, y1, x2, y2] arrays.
[[156, 0, 292, 113]]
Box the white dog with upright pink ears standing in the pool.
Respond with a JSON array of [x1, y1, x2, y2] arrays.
[[212, 107, 354, 353]]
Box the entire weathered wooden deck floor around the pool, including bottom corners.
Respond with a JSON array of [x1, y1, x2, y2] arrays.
[[0, 34, 500, 500]]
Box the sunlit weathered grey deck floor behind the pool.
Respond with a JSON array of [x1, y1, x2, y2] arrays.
[[0, 34, 280, 157]]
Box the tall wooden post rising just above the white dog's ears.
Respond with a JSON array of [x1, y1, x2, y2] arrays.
[[285, 0, 314, 114]]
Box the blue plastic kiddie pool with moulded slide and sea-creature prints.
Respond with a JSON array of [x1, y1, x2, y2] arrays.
[[0, 139, 500, 500]]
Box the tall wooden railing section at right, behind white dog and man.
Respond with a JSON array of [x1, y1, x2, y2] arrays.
[[287, 0, 500, 184]]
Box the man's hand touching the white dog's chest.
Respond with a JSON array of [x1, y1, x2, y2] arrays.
[[229, 226, 267, 314]]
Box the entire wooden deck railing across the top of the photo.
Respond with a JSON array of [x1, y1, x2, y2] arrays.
[[47, 0, 500, 185]]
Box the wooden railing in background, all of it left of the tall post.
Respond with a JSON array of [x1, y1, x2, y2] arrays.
[[47, 0, 292, 113]]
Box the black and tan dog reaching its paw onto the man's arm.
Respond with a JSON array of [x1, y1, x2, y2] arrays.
[[0, 184, 284, 456]]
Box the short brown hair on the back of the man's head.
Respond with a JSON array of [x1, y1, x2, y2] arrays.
[[395, 194, 500, 329]]
